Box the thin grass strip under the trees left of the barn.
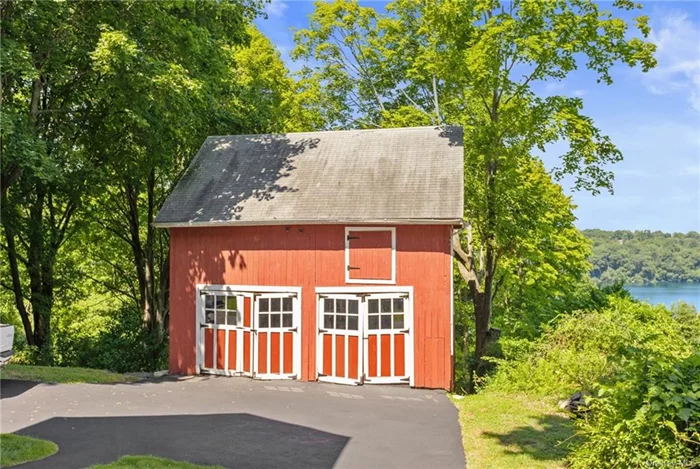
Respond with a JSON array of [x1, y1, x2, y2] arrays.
[[0, 364, 137, 384]]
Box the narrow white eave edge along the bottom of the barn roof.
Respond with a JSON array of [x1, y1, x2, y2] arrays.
[[152, 218, 462, 228]]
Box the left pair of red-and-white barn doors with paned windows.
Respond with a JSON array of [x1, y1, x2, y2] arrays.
[[196, 285, 301, 379]]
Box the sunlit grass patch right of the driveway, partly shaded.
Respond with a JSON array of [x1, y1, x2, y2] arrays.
[[453, 392, 576, 469]]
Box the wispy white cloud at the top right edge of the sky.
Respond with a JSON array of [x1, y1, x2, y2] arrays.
[[644, 11, 700, 112]]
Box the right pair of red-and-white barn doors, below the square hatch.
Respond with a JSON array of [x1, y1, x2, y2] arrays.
[[317, 289, 413, 385]]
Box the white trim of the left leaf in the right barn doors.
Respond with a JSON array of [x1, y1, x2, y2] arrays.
[[316, 293, 364, 385]]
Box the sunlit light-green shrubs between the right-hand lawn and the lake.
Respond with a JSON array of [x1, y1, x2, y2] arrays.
[[487, 298, 698, 398]]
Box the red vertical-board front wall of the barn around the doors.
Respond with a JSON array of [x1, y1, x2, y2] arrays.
[[170, 225, 452, 389]]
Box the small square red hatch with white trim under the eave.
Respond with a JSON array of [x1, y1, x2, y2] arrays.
[[346, 228, 395, 283]]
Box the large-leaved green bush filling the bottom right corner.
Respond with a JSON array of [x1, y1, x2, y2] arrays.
[[571, 350, 700, 468]]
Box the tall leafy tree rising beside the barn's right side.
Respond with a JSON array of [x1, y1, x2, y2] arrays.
[[296, 0, 655, 370]]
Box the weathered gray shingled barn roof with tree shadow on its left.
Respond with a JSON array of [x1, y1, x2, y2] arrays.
[[155, 127, 464, 227]]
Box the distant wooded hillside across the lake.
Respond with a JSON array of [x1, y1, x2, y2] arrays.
[[583, 230, 700, 284]]
